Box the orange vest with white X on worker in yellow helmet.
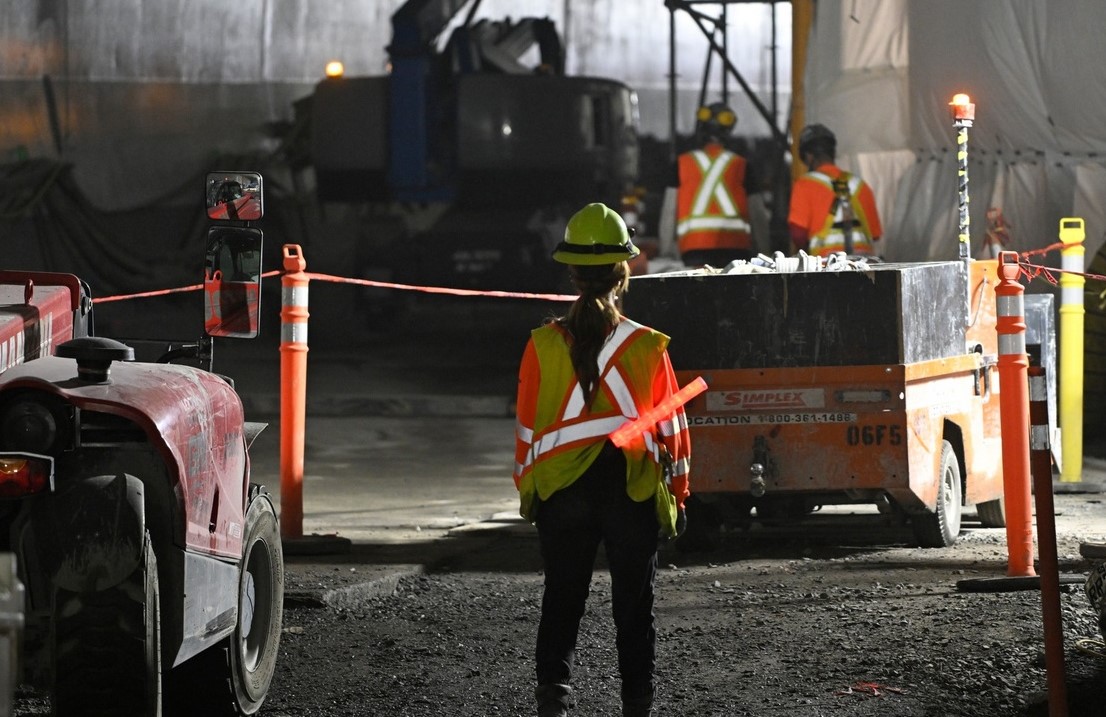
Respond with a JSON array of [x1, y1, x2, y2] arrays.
[[676, 144, 752, 253]]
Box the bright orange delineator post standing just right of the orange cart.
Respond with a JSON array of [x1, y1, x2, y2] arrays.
[[994, 251, 1035, 576]]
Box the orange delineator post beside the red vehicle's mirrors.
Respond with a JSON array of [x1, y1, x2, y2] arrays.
[[280, 245, 311, 538]]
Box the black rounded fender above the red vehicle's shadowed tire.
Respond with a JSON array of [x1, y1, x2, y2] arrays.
[[30, 474, 146, 593]]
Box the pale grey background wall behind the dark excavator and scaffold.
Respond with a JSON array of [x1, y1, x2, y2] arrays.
[[0, 0, 791, 209]]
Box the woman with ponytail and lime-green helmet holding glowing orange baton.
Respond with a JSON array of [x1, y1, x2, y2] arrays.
[[514, 204, 690, 717]]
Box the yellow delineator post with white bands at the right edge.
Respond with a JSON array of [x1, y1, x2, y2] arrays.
[[1060, 217, 1086, 482]]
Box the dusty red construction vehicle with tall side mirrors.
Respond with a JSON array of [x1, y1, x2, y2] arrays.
[[0, 172, 284, 717]]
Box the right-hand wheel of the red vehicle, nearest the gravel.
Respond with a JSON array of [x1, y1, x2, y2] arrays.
[[167, 493, 284, 717]]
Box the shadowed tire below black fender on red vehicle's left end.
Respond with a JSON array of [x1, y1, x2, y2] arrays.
[[51, 532, 161, 717]]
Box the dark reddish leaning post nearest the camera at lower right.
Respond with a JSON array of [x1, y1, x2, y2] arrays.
[[1027, 366, 1067, 717]]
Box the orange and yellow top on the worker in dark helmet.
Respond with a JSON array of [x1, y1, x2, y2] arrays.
[[787, 164, 883, 257]]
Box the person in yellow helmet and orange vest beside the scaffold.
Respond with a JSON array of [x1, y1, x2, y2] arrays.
[[676, 102, 753, 267]]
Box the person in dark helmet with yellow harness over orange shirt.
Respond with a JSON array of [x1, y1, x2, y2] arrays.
[[787, 124, 884, 257]]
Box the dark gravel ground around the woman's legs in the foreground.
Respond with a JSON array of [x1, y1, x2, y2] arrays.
[[254, 496, 1106, 717]]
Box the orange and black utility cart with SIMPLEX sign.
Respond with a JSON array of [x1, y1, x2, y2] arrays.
[[626, 261, 1005, 549]]
